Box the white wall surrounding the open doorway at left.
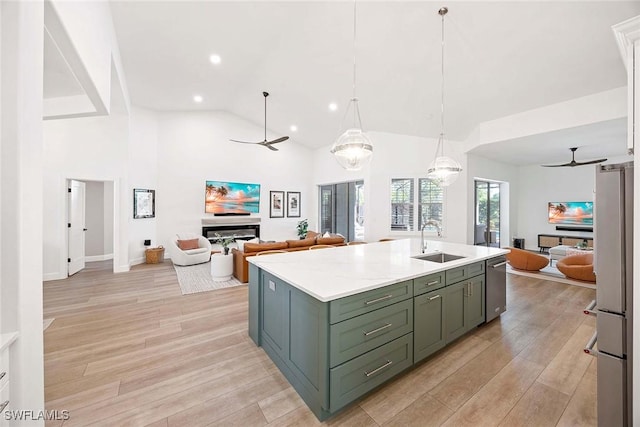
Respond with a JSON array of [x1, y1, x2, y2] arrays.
[[43, 115, 131, 280]]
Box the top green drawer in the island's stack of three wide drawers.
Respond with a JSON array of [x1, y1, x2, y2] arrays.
[[329, 280, 413, 324]]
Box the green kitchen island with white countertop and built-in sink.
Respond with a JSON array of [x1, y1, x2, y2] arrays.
[[249, 239, 508, 420]]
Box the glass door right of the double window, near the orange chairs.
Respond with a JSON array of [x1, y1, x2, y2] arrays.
[[473, 180, 500, 248]]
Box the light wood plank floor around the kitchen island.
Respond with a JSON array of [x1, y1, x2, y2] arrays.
[[44, 261, 596, 426]]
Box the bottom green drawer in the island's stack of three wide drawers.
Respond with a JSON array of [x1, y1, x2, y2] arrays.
[[330, 333, 413, 412]]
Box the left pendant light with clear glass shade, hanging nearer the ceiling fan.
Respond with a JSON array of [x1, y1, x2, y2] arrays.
[[331, 0, 373, 171]]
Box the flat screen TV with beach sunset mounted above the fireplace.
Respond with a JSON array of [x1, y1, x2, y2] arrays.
[[204, 181, 260, 215]]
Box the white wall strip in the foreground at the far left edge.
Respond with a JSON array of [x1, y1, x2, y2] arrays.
[[0, 0, 44, 425]]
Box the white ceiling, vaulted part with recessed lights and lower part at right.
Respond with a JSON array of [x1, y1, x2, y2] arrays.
[[89, 1, 640, 164]]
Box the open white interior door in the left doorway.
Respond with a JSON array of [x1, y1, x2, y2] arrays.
[[68, 180, 87, 276]]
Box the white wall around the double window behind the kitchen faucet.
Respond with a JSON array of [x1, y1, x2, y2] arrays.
[[310, 132, 467, 243]]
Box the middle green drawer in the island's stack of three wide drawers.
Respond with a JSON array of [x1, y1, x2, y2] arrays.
[[329, 299, 413, 367]]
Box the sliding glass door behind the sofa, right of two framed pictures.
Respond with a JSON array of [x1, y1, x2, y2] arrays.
[[318, 181, 365, 241]]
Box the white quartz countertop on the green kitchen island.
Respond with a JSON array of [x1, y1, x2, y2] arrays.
[[247, 238, 509, 302]]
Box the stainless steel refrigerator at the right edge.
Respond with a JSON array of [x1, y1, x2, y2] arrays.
[[585, 162, 633, 426]]
